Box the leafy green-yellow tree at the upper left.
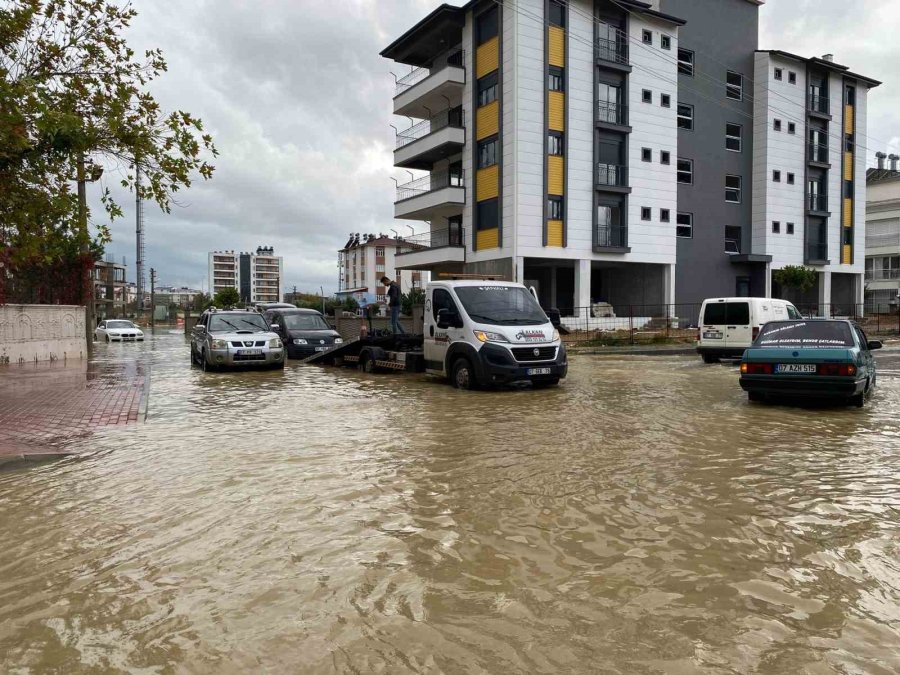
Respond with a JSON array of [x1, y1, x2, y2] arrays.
[[0, 0, 217, 302]]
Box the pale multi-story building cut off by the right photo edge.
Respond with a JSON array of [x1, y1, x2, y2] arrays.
[[865, 152, 900, 313]]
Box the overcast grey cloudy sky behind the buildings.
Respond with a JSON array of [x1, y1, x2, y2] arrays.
[[95, 0, 900, 293]]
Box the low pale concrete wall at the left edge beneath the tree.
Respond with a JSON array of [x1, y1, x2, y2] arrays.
[[0, 305, 87, 363]]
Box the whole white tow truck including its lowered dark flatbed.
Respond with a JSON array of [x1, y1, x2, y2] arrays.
[[304, 279, 568, 389]]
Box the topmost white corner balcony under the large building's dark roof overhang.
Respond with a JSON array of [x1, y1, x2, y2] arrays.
[[394, 49, 466, 119]]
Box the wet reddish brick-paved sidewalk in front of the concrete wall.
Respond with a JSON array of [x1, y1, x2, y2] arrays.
[[0, 361, 150, 464]]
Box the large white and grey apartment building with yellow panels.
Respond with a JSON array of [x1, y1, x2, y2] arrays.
[[382, 0, 878, 312]]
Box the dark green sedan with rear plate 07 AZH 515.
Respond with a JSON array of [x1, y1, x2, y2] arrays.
[[741, 319, 881, 408]]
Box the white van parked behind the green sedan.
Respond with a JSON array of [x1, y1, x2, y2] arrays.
[[697, 298, 803, 363]]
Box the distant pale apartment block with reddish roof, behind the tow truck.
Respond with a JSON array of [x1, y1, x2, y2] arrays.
[[338, 233, 428, 302]]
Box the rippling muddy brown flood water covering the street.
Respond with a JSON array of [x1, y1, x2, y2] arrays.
[[0, 334, 900, 674]]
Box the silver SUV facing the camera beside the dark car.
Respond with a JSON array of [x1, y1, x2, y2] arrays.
[[191, 308, 284, 370]]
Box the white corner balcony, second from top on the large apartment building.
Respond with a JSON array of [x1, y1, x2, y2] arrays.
[[394, 108, 466, 170]]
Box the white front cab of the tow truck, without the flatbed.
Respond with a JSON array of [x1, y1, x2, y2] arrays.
[[424, 280, 568, 389]]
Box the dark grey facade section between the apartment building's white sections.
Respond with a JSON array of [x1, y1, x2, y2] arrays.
[[660, 0, 765, 303]]
